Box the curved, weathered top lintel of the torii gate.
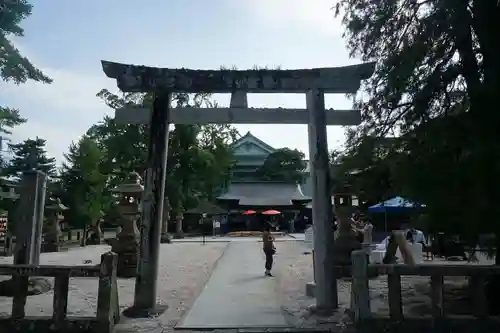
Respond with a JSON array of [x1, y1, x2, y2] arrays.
[[101, 60, 375, 93]]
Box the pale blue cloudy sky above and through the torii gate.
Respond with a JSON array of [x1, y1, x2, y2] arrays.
[[0, 0, 356, 160]]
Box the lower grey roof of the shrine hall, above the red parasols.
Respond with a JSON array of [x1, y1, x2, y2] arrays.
[[217, 182, 312, 206]]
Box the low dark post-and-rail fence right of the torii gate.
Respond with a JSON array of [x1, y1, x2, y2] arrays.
[[350, 250, 500, 332]]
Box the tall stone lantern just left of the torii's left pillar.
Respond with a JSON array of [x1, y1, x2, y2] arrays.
[[111, 172, 144, 278]]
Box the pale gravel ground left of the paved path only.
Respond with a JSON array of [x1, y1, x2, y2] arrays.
[[0, 243, 227, 333]]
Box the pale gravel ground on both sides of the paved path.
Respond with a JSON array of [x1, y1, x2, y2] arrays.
[[0, 241, 490, 333]]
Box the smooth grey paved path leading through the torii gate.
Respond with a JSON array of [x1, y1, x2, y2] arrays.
[[177, 241, 287, 329]]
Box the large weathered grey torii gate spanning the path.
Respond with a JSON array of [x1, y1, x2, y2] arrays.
[[102, 61, 375, 316]]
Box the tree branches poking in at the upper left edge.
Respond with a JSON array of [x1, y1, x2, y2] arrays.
[[0, 0, 52, 134]]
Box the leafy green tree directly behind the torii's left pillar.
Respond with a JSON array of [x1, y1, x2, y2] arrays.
[[87, 90, 237, 216]]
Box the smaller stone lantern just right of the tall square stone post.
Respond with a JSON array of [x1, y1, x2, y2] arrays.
[[42, 198, 68, 252]]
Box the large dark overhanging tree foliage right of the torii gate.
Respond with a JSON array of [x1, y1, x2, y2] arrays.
[[337, 0, 500, 237]]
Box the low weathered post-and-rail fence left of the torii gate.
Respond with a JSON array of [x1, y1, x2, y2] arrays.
[[0, 252, 119, 333]]
